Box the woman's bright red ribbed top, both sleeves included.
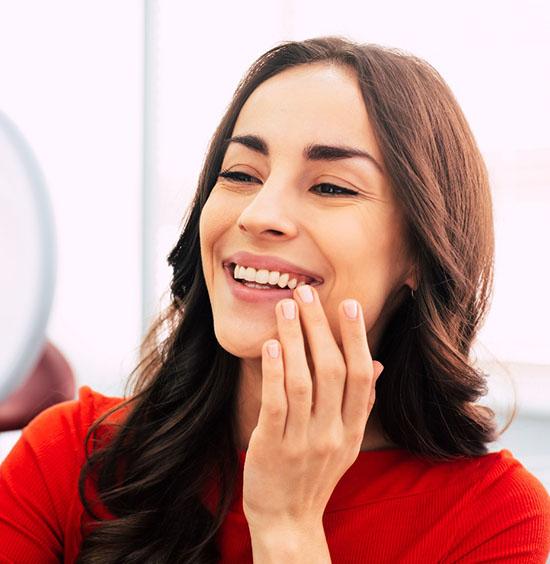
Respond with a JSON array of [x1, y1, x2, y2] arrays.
[[0, 386, 550, 564]]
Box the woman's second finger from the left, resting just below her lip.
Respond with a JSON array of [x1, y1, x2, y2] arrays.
[[275, 299, 312, 444]]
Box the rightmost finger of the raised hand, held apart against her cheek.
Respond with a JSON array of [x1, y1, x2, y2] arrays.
[[338, 300, 375, 436]]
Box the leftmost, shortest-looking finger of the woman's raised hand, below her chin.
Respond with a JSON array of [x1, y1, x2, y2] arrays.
[[258, 339, 287, 440]]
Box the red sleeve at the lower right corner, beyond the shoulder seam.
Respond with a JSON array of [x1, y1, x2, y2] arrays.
[[445, 452, 550, 564]]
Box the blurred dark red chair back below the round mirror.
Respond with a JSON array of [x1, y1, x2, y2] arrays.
[[0, 340, 76, 431]]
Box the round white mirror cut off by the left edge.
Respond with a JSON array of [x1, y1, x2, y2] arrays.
[[0, 112, 57, 401]]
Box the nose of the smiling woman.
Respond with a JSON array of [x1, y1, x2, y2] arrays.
[[238, 176, 300, 238]]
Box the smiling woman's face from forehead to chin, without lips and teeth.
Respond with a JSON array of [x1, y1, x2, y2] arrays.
[[200, 63, 415, 359]]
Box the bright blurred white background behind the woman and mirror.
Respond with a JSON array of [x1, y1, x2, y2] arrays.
[[0, 0, 550, 490]]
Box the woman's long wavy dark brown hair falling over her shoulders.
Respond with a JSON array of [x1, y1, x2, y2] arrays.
[[78, 37, 512, 564]]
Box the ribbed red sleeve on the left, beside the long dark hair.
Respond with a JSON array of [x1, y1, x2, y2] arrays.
[[0, 386, 93, 564]]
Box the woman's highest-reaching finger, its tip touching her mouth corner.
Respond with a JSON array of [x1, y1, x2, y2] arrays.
[[296, 285, 346, 422]]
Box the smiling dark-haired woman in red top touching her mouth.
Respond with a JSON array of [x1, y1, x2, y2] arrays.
[[0, 37, 550, 563]]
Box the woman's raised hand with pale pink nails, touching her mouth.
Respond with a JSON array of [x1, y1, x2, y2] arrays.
[[243, 286, 383, 530]]
